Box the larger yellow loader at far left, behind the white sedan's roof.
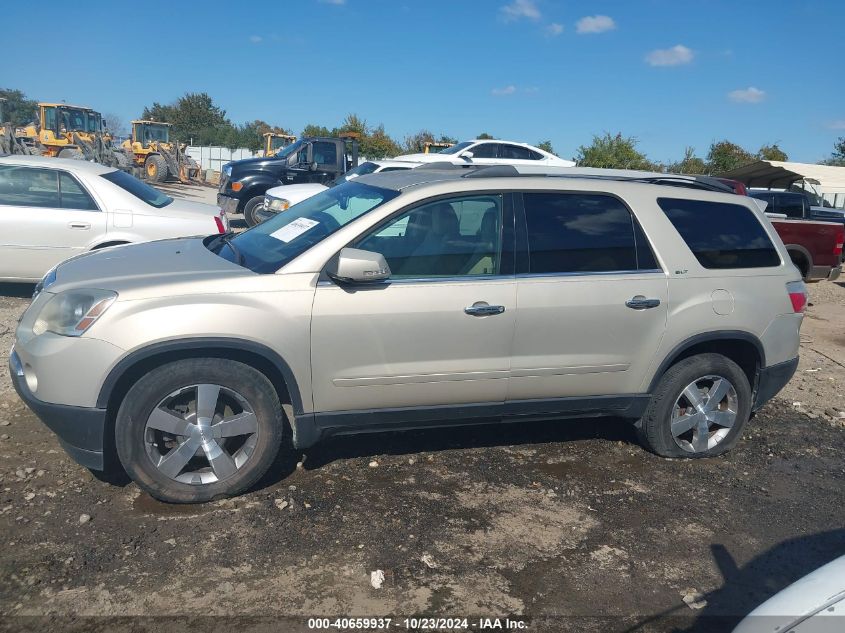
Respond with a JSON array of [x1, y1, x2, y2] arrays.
[[15, 103, 129, 169]]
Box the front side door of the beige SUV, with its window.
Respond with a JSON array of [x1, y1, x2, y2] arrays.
[[311, 192, 516, 422]]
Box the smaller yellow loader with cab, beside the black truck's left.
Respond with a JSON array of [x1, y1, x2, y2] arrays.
[[123, 120, 200, 182]]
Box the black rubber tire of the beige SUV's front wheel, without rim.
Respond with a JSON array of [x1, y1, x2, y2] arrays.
[[115, 358, 284, 503]]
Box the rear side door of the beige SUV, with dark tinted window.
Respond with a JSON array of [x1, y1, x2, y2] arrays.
[[508, 191, 668, 404]]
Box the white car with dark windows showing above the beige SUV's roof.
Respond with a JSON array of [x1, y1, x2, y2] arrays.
[[395, 139, 575, 168]]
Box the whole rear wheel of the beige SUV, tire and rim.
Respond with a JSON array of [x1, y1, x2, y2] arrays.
[[637, 354, 752, 458]]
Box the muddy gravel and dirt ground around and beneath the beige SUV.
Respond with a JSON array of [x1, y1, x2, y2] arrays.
[[0, 282, 845, 631]]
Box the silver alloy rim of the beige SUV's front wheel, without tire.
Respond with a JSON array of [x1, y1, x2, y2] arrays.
[[144, 384, 258, 485]]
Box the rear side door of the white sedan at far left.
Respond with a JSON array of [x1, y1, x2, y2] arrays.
[[0, 165, 107, 279]]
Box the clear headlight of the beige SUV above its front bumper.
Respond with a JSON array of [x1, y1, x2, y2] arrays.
[[32, 289, 117, 336]]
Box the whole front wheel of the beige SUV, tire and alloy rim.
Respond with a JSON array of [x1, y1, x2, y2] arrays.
[[115, 358, 283, 503]]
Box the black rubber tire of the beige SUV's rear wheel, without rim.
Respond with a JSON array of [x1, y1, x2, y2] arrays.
[[637, 353, 752, 459]]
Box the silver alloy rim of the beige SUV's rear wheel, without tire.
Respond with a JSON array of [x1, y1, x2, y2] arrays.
[[672, 376, 737, 453]]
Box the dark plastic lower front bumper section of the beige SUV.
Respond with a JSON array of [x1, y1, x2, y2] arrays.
[[9, 350, 106, 470]]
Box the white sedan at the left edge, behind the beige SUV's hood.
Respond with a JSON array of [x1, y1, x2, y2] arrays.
[[0, 156, 229, 282]]
